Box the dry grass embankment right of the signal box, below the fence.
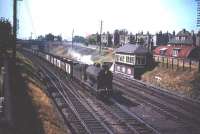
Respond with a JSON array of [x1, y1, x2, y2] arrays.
[[142, 66, 200, 100]]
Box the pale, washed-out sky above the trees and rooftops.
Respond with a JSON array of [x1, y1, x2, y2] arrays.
[[0, 0, 197, 39]]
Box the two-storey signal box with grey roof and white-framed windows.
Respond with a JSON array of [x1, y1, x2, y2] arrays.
[[114, 44, 152, 78]]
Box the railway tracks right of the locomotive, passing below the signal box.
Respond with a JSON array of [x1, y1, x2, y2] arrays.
[[114, 74, 200, 132]]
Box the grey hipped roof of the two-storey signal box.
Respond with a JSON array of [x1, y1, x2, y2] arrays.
[[116, 44, 148, 54]]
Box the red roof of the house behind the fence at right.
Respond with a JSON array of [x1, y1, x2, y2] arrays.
[[153, 45, 195, 58]]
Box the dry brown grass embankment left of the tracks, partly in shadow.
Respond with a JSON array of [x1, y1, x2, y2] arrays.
[[15, 53, 69, 134]]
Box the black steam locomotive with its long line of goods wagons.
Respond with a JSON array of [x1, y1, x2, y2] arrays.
[[27, 50, 113, 95]]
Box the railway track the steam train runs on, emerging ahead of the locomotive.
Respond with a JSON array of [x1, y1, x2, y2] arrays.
[[64, 69, 159, 134]]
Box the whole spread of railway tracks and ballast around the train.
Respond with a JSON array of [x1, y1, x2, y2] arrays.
[[19, 48, 200, 134]]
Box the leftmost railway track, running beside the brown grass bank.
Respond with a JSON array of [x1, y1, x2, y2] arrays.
[[24, 52, 113, 134]]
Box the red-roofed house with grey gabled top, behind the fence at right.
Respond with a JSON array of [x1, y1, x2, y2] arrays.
[[153, 29, 199, 61]]
